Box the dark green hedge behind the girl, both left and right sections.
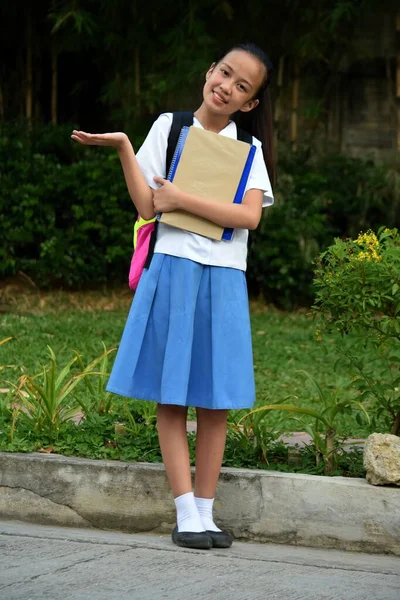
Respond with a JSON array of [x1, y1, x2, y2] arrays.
[[0, 123, 400, 308]]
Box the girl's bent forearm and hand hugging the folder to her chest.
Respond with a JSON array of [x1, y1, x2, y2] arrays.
[[153, 177, 263, 229]]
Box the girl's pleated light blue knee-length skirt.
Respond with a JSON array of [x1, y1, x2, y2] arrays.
[[107, 254, 255, 409]]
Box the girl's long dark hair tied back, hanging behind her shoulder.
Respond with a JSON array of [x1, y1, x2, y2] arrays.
[[216, 43, 276, 185]]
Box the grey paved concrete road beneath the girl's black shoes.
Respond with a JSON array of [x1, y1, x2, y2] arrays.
[[0, 521, 400, 600]]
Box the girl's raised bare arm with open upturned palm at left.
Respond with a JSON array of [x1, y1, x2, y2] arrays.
[[71, 130, 155, 220]]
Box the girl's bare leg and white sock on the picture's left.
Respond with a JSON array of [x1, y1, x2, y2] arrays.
[[157, 404, 204, 536]]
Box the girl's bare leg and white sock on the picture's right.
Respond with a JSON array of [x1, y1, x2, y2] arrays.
[[195, 408, 228, 531]]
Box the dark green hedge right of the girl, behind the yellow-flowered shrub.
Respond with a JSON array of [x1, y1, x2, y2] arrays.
[[248, 148, 400, 308]]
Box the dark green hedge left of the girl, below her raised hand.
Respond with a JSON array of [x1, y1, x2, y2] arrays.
[[0, 121, 135, 287]]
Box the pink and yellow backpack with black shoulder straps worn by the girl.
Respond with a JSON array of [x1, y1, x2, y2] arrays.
[[129, 112, 253, 290]]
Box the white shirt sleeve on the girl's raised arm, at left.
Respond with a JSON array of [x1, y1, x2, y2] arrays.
[[136, 113, 172, 189]]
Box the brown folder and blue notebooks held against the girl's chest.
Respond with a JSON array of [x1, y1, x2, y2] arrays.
[[159, 127, 256, 241]]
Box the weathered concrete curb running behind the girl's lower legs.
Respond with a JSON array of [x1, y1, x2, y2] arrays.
[[0, 453, 400, 556]]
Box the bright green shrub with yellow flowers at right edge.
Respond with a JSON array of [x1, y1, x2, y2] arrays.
[[314, 228, 400, 435]]
